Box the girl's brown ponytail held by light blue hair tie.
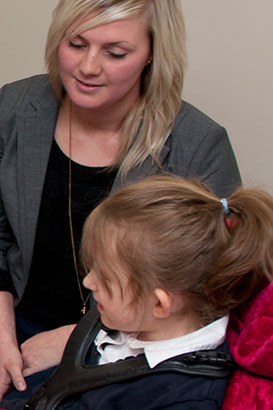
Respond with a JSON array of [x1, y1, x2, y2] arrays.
[[205, 188, 273, 314]]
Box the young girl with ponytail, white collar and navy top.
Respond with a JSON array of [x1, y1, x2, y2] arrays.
[[3, 176, 273, 410]]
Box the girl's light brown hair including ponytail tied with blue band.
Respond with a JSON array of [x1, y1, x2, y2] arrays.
[[82, 176, 273, 324]]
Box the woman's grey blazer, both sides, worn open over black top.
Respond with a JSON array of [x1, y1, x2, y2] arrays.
[[0, 75, 238, 303]]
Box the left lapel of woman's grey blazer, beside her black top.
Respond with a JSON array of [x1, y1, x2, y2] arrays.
[[17, 107, 58, 278]]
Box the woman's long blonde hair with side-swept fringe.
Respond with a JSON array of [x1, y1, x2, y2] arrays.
[[45, 0, 186, 176]]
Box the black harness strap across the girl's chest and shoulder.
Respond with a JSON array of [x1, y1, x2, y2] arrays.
[[24, 308, 236, 410]]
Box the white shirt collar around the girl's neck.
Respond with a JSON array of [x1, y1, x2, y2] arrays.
[[95, 315, 229, 368]]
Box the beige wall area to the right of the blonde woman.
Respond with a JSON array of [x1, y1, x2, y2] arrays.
[[182, 0, 273, 194]]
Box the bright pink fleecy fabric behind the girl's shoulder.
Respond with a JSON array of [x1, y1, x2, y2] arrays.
[[222, 284, 273, 410]]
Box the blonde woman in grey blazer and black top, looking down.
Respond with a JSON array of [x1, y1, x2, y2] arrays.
[[0, 0, 240, 397]]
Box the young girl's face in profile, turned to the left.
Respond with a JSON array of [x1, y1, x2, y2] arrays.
[[83, 263, 153, 334]]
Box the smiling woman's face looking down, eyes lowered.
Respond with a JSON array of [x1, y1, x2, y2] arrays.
[[58, 17, 151, 113]]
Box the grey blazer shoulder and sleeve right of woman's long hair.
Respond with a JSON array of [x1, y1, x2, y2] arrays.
[[166, 103, 241, 197]]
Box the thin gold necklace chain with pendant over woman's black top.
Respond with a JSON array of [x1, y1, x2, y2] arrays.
[[68, 101, 90, 315]]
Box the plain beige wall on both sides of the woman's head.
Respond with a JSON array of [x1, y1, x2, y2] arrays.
[[0, 0, 273, 193]]
